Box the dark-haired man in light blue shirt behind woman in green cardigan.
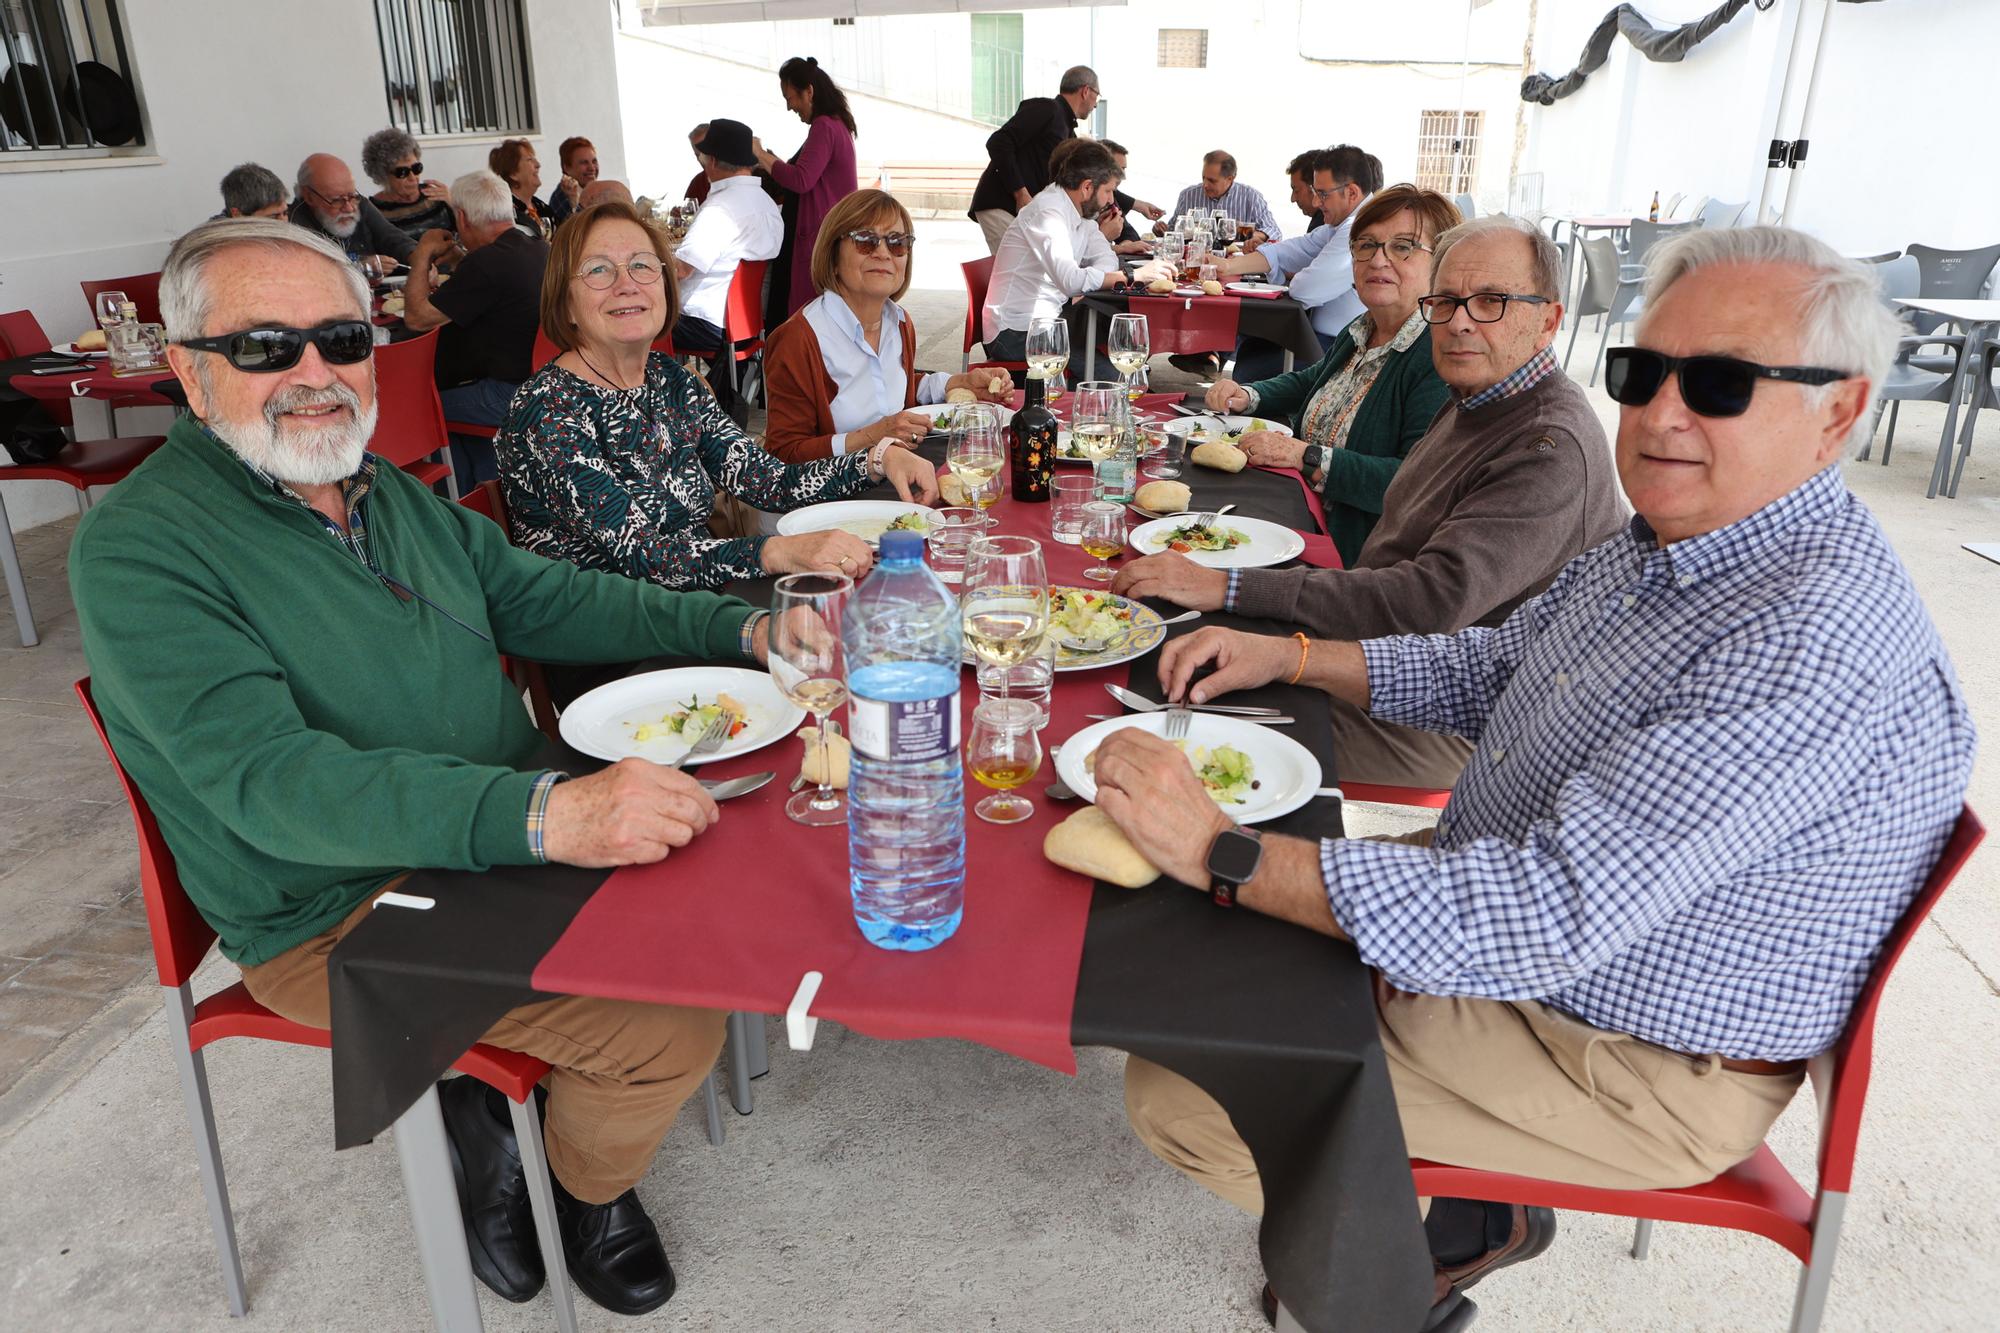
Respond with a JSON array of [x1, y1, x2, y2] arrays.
[[1220, 144, 1382, 384]]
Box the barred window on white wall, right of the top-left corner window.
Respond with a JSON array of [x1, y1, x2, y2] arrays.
[[374, 0, 540, 136]]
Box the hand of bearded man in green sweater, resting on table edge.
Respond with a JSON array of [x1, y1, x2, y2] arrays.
[[542, 759, 716, 867]]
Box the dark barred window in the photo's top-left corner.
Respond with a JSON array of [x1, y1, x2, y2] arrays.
[[0, 0, 146, 160]]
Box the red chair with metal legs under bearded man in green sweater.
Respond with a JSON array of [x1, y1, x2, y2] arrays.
[[76, 677, 576, 1329]]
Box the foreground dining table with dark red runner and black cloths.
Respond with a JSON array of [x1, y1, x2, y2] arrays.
[[328, 440, 1432, 1333]]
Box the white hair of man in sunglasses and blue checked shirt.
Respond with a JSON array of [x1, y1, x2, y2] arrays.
[[1638, 226, 1908, 450]]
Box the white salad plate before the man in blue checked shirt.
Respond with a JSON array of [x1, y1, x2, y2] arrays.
[[1056, 711, 1320, 825]]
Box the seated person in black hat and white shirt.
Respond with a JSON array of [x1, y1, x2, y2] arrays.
[[674, 120, 784, 414]]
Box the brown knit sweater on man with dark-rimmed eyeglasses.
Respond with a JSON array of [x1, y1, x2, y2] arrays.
[[1234, 372, 1624, 638]]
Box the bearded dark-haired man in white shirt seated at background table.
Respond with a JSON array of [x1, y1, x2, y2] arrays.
[[980, 142, 1166, 376]]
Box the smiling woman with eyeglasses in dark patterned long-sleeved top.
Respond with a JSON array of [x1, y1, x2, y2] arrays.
[[498, 202, 938, 588]]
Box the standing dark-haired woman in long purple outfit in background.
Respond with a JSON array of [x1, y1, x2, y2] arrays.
[[752, 56, 860, 328]]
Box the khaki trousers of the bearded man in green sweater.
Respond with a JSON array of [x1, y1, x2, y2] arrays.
[[242, 881, 724, 1203]]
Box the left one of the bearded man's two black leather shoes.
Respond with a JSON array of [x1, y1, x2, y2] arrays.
[[438, 1079, 546, 1303]]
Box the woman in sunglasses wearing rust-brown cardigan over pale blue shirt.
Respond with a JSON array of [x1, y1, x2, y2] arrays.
[[764, 190, 1014, 462]]
